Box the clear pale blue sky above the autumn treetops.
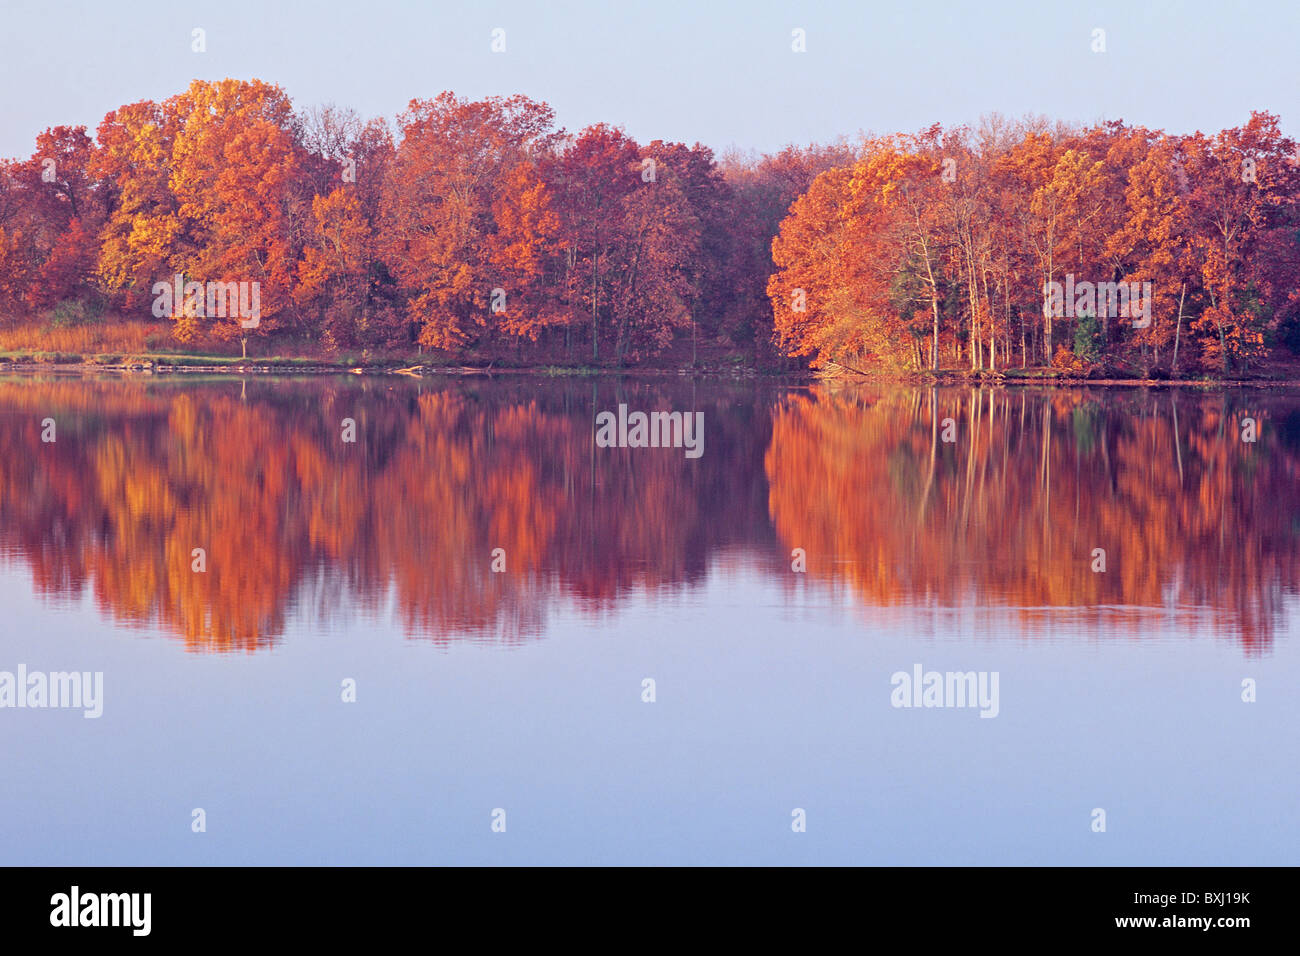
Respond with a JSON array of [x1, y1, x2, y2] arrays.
[[0, 0, 1300, 156]]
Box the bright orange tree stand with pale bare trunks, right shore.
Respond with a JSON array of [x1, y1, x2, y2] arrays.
[[768, 113, 1300, 375]]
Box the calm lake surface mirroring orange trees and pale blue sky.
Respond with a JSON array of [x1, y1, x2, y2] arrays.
[[0, 377, 1300, 865]]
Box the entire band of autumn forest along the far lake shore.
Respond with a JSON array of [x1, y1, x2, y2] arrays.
[[0, 79, 1300, 377]]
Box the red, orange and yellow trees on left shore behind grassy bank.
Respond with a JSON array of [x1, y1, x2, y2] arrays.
[[0, 79, 853, 364]]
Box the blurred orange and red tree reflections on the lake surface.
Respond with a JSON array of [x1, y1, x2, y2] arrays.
[[0, 378, 1300, 653]]
